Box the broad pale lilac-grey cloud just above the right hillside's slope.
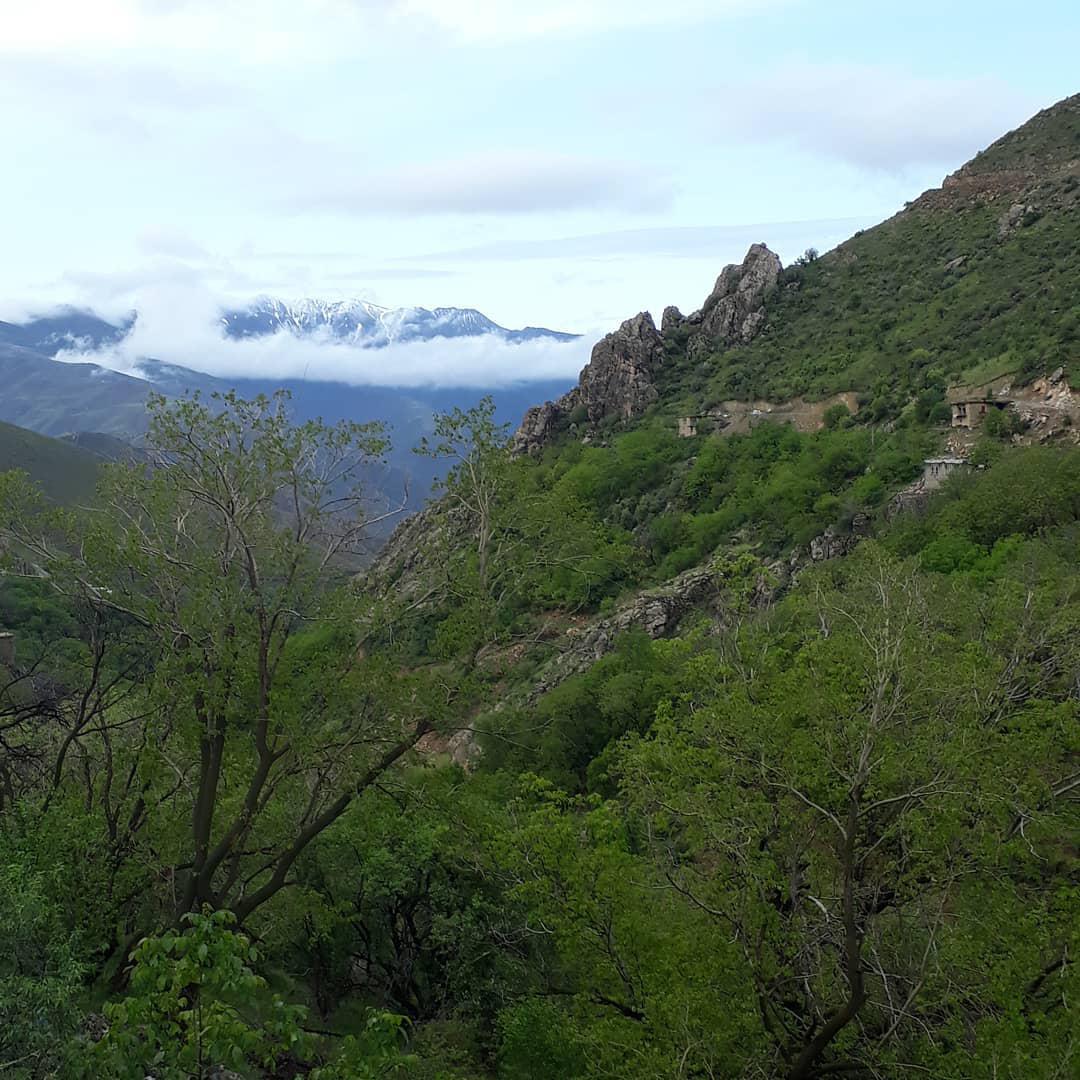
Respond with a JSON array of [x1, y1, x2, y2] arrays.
[[710, 65, 1037, 172]]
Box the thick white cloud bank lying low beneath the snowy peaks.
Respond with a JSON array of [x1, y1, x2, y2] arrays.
[[57, 283, 592, 389]]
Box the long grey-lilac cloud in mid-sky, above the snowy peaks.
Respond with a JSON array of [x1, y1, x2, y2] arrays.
[[293, 151, 674, 215]]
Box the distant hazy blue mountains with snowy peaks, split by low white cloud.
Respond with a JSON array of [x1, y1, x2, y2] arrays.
[[0, 298, 577, 505]]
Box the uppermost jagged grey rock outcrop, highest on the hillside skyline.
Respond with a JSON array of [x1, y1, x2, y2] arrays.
[[687, 244, 783, 355]]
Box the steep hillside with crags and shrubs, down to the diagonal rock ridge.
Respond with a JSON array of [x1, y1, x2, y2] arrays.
[[376, 96, 1080, 708]]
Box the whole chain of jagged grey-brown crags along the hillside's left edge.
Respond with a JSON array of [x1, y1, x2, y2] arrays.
[[513, 244, 782, 455]]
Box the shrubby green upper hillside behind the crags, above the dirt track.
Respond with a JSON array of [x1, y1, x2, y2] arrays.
[[665, 96, 1080, 419]]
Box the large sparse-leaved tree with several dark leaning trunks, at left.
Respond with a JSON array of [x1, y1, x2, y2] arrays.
[[0, 394, 445, 920]]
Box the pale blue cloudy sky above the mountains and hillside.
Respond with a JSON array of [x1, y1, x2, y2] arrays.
[[0, 0, 1080, 383]]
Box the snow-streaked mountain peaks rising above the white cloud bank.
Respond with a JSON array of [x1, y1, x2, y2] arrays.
[[221, 297, 578, 348]]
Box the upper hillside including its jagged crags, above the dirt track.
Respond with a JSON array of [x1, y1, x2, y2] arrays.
[[515, 95, 1080, 454]]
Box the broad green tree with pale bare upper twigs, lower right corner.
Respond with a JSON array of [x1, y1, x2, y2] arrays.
[[623, 544, 1077, 1080]]
